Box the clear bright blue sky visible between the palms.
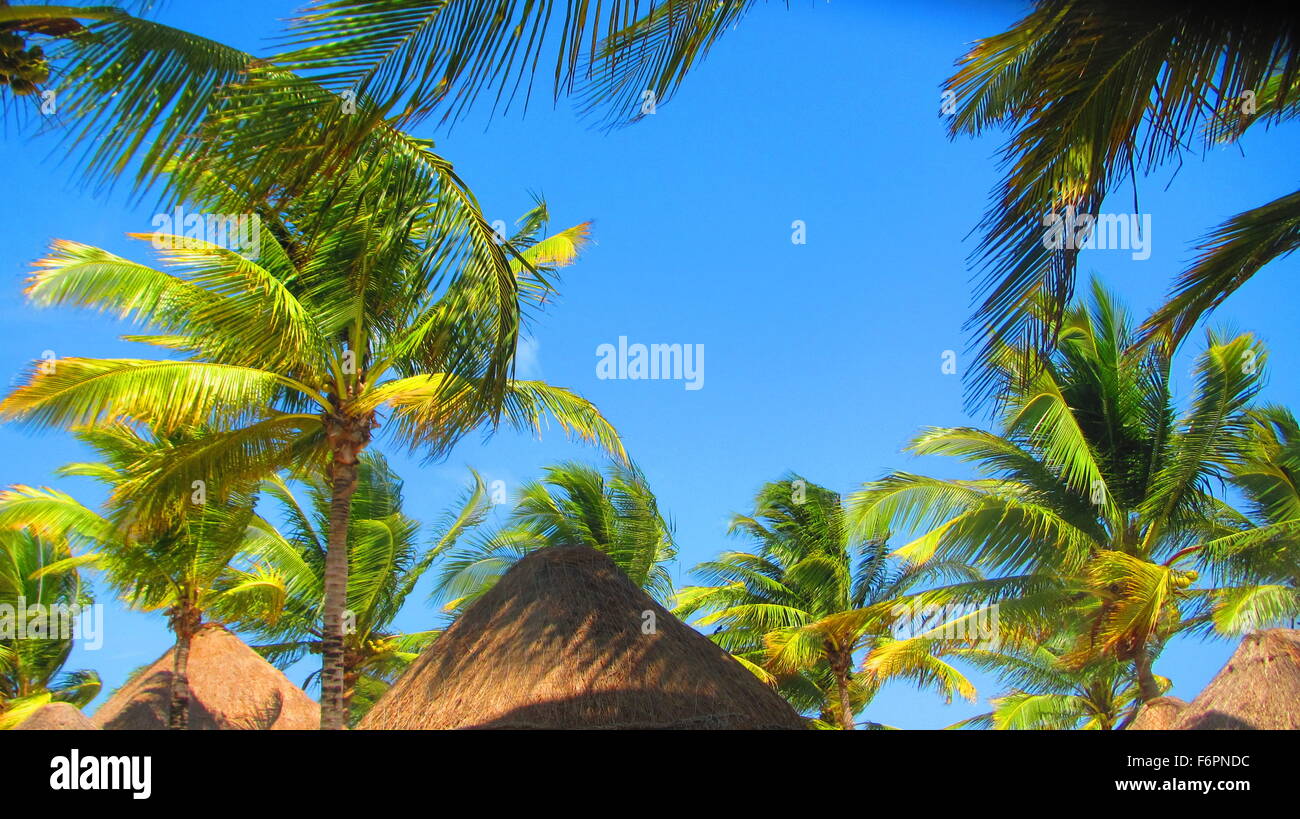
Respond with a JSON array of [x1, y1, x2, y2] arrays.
[[0, 0, 1300, 728]]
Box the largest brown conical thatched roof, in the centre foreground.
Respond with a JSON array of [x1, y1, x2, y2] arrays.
[[360, 546, 803, 729]]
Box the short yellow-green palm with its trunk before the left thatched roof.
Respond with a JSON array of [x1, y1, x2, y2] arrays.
[[0, 425, 285, 731]]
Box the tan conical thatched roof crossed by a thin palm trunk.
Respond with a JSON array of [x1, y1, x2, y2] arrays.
[[94, 625, 320, 731]]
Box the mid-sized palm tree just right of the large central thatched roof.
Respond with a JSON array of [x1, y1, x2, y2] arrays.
[[676, 476, 975, 729]]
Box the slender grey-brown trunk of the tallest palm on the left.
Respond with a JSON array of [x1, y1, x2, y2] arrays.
[[321, 460, 356, 731]]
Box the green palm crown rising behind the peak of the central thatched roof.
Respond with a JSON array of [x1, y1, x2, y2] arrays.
[[434, 463, 677, 612]]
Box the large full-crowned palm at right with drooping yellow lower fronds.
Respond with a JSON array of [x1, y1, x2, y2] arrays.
[[850, 285, 1265, 701]]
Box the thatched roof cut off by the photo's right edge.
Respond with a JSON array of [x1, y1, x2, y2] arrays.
[[1174, 628, 1300, 731]]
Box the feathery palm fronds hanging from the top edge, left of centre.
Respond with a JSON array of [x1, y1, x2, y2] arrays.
[[282, 0, 757, 130]]
